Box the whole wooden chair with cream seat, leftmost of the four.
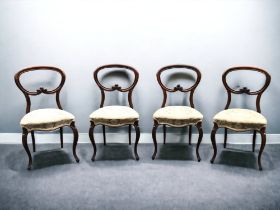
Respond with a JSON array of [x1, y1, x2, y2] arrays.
[[14, 66, 79, 170]]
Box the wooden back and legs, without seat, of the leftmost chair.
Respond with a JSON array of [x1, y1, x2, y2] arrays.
[[14, 66, 79, 170]]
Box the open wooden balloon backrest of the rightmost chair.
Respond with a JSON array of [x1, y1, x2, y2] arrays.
[[222, 66, 271, 113]]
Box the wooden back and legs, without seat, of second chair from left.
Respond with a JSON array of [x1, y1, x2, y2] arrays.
[[89, 64, 140, 161]]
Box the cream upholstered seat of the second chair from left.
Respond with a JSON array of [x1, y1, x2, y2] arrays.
[[89, 106, 139, 127]]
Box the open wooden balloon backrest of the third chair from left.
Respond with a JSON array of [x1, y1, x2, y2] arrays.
[[157, 65, 201, 108]]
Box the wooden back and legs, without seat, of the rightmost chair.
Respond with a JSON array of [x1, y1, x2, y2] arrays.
[[210, 66, 271, 170]]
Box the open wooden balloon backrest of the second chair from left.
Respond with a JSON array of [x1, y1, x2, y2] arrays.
[[93, 64, 139, 108]]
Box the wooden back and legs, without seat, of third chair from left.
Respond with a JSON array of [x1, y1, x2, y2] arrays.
[[152, 65, 203, 161]]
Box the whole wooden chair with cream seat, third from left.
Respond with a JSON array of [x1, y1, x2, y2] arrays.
[[152, 65, 203, 161]]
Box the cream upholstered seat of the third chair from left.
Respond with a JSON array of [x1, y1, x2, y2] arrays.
[[153, 106, 203, 127]]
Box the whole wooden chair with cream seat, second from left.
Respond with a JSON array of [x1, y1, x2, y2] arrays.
[[89, 64, 140, 161]]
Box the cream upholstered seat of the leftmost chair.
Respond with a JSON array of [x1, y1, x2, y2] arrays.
[[20, 109, 75, 131]]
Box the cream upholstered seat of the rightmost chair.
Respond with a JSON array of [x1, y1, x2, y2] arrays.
[[214, 109, 267, 131]]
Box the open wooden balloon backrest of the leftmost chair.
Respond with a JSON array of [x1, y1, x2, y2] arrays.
[[14, 66, 66, 113]]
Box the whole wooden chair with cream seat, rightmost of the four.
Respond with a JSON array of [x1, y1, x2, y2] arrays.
[[211, 66, 271, 170]]
